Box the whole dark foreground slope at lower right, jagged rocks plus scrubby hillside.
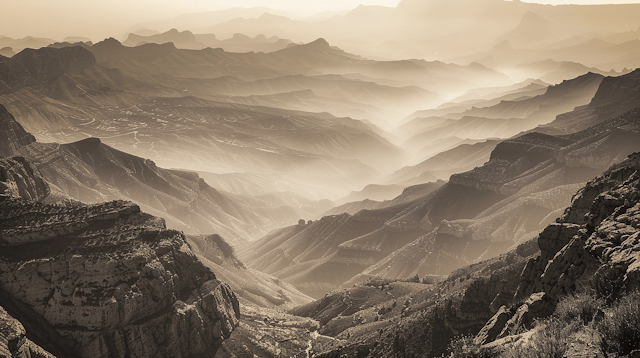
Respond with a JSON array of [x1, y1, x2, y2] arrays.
[[293, 153, 640, 357]]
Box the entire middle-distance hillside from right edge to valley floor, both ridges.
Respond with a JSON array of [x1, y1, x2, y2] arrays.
[[241, 105, 640, 297]]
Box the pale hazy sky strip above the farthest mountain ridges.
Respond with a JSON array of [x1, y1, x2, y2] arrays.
[[0, 0, 639, 40]]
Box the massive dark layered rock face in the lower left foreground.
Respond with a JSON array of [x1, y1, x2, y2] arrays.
[[0, 159, 239, 357]]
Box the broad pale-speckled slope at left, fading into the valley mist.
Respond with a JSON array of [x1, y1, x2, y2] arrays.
[[2, 41, 410, 196]]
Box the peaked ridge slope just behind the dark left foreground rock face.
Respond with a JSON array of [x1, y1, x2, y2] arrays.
[[16, 138, 280, 243]]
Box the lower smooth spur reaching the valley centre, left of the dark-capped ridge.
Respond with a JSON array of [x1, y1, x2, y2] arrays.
[[241, 179, 502, 297]]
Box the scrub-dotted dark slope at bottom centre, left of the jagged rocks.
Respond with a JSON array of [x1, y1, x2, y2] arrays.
[[292, 235, 537, 357]]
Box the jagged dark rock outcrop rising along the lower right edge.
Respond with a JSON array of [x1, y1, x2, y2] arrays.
[[476, 153, 640, 344]]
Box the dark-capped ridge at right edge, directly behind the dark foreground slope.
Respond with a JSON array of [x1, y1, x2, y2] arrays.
[[357, 109, 640, 281]]
